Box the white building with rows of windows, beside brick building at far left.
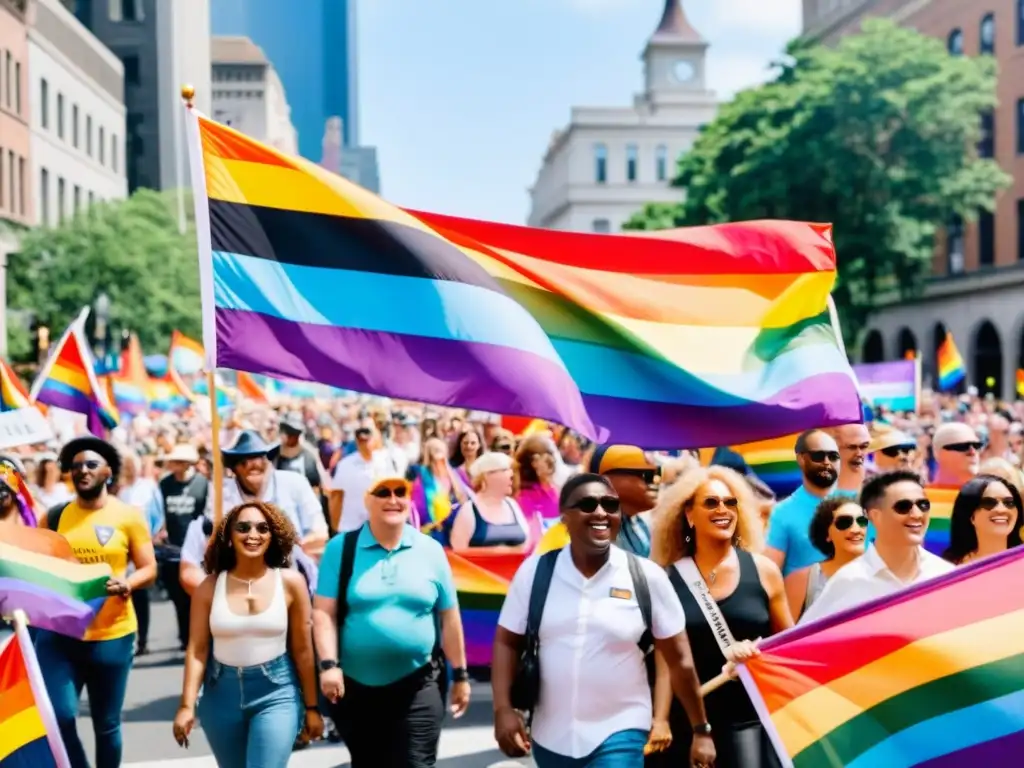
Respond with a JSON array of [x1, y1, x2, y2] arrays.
[[29, 0, 128, 226]]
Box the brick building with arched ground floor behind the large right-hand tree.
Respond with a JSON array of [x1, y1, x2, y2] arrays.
[[803, 0, 1024, 396]]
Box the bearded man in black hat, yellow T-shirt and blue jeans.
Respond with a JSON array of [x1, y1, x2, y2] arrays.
[[37, 435, 157, 768]]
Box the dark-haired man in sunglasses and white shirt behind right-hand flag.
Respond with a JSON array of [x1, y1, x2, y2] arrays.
[[800, 470, 954, 625]]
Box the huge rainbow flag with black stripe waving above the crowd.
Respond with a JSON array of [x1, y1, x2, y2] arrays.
[[188, 112, 861, 449]]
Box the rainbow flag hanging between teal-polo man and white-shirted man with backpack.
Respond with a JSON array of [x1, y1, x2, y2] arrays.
[[445, 550, 525, 667]]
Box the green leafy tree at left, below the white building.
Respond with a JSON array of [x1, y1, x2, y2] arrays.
[[7, 189, 201, 358]]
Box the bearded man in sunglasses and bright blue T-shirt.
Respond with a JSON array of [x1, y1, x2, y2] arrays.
[[765, 429, 840, 577]]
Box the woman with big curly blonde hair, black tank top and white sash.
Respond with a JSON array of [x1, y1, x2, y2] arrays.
[[651, 466, 793, 768]]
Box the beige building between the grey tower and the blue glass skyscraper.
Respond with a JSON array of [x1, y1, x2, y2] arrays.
[[210, 37, 299, 155]]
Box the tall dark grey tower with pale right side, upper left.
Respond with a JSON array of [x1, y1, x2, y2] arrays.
[[62, 0, 211, 191]]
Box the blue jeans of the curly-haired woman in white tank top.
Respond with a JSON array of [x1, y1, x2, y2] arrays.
[[197, 655, 305, 768]]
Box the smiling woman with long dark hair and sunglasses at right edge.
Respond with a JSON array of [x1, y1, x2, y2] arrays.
[[942, 474, 1021, 565]]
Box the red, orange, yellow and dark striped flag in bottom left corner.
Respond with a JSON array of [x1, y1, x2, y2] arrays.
[[0, 626, 71, 768]]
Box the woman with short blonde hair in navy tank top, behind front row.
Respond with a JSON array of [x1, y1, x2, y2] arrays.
[[452, 453, 529, 552]]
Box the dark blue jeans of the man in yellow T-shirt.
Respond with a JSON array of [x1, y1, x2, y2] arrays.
[[36, 631, 135, 768]]
